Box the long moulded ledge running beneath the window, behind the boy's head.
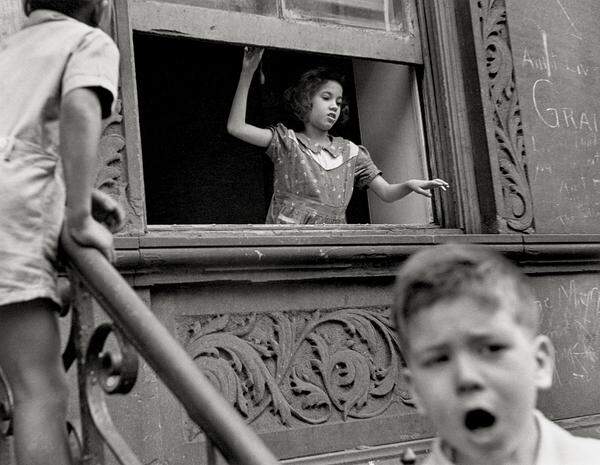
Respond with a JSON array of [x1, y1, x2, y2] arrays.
[[115, 225, 600, 285]]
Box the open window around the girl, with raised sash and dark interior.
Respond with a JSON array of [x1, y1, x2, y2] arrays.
[[123, 0, 468, 227]]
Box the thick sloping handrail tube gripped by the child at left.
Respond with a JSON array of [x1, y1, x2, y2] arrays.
[[61, 234, 279, 465]]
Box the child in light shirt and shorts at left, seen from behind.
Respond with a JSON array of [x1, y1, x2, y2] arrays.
[[0, 0, 123, 465]]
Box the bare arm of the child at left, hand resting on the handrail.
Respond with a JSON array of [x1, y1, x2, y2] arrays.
[[60, 88, 114, 261]]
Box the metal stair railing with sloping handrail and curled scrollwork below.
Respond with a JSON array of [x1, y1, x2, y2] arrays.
[[0, 231, 279, 465]]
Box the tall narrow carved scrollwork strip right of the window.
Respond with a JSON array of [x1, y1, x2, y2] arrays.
[[478, 0, 534, 233]]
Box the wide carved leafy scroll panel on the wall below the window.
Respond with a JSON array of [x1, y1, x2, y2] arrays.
[[178, 308, 412, 440]]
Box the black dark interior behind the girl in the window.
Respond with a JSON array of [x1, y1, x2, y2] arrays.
[[133, 33, 369, 225]]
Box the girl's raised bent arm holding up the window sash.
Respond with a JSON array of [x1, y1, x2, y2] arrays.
[[227, 47, 273, 147]]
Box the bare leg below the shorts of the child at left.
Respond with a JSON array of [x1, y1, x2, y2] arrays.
[[0, 299, 72, 465]]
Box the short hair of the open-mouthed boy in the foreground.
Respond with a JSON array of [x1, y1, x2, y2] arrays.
[[392, 244, 539, 349]]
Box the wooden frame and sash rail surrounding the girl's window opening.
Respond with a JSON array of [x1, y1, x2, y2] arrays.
[[117, 0, 486, 237]]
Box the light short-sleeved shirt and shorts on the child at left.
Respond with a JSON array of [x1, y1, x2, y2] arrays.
[[0, 10, 119, 305]]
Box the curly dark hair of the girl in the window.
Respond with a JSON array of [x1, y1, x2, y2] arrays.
[[283, 67, 350, 125]]
